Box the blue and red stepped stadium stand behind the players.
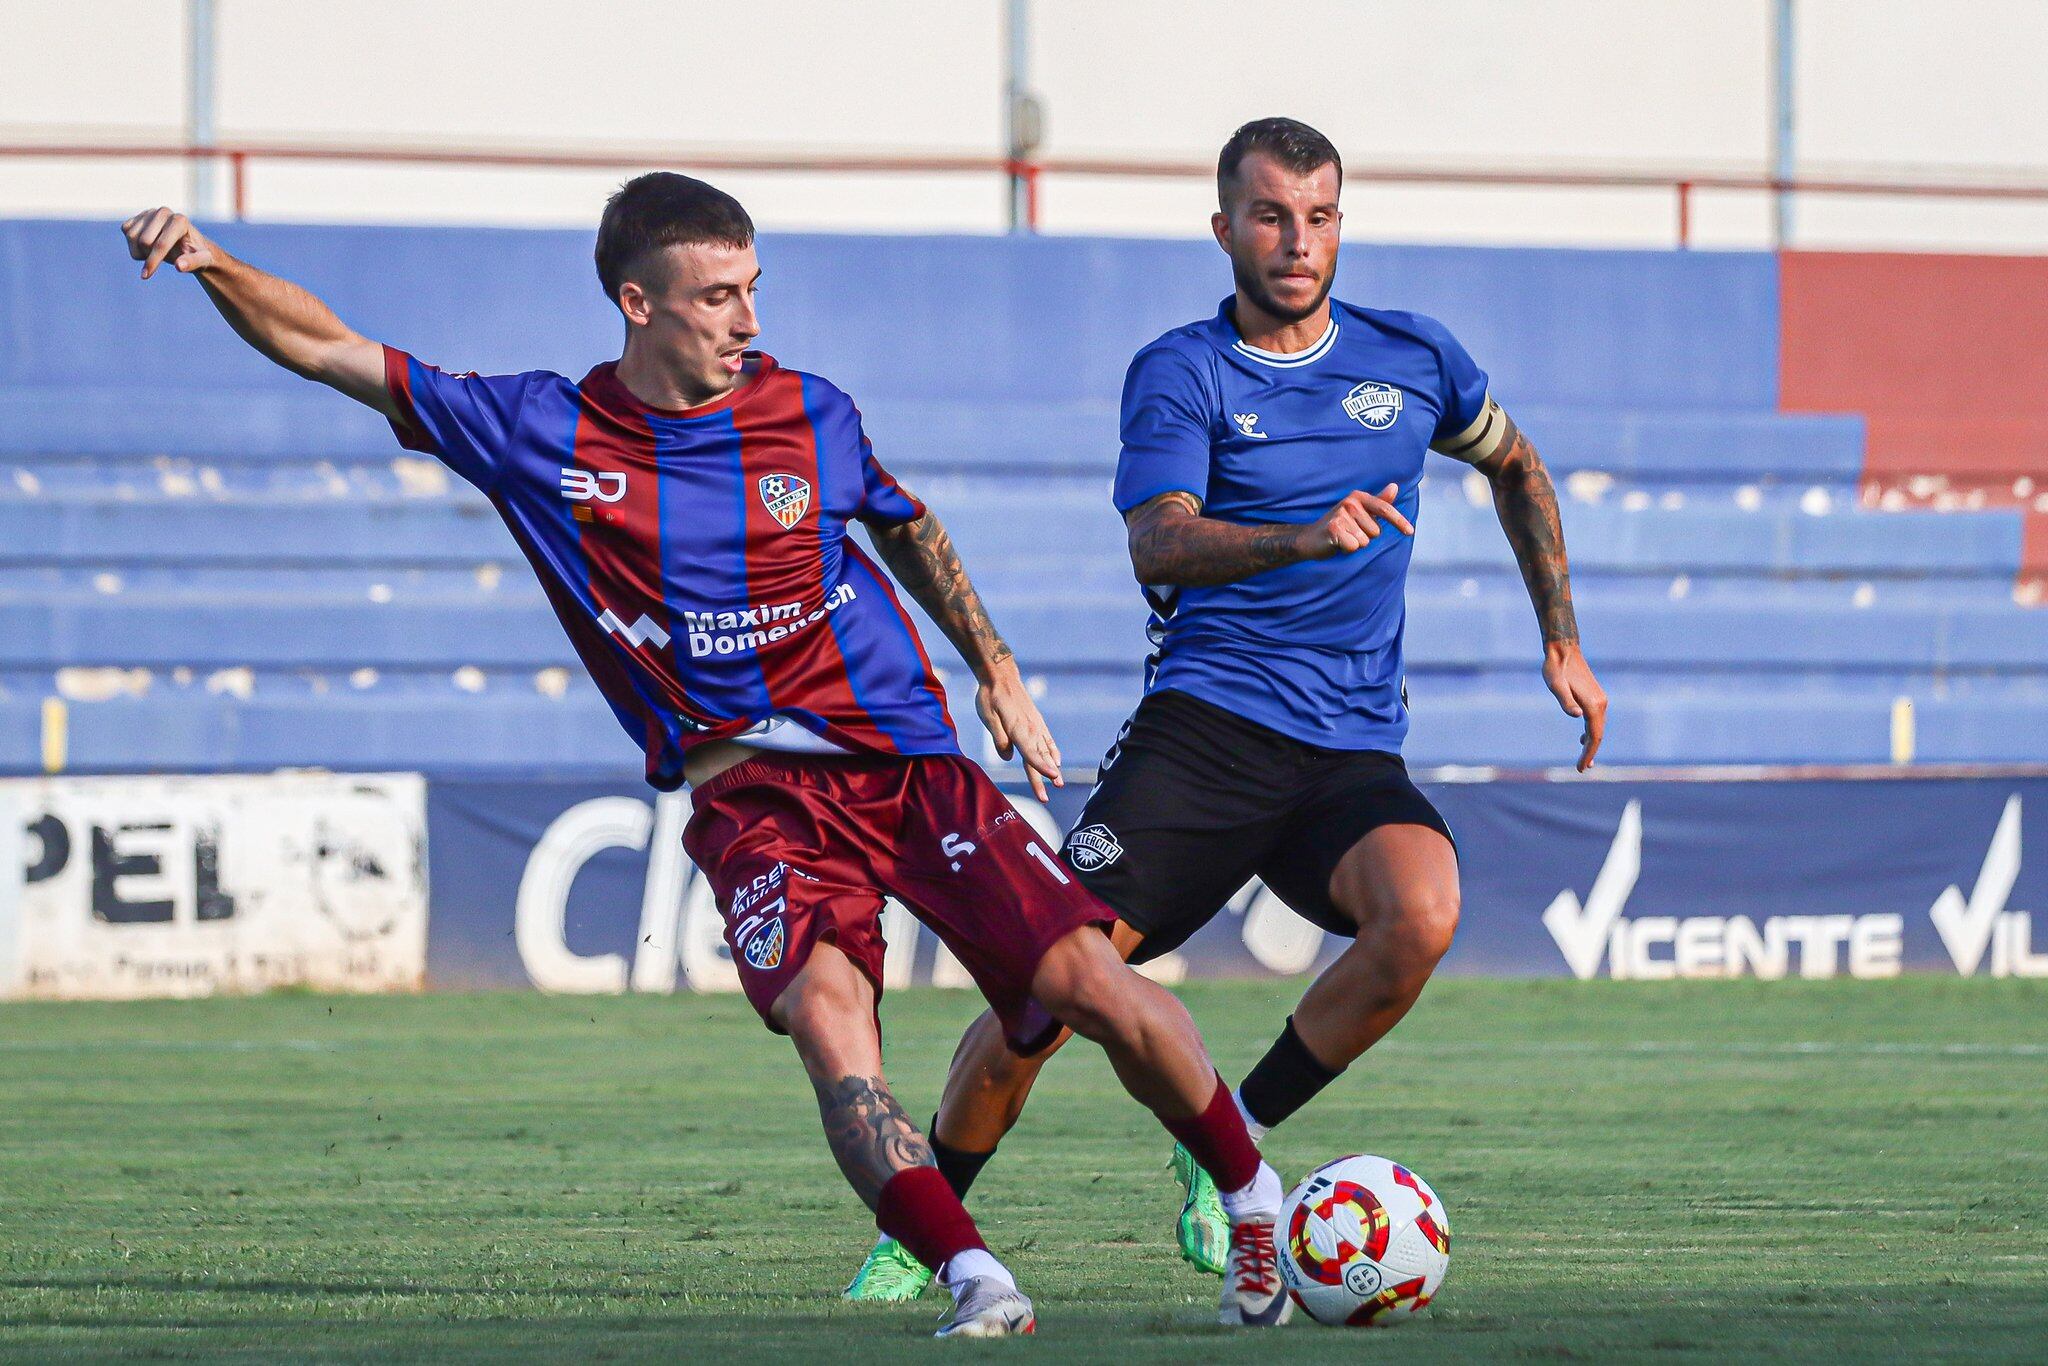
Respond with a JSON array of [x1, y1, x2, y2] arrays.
[[0, 221, 2048, 772]]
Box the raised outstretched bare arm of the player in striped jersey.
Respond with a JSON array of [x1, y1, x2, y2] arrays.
[[121, 209, 399, 418]]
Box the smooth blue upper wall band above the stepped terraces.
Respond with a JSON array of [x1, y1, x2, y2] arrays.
[[0, 221, 1778, 455]]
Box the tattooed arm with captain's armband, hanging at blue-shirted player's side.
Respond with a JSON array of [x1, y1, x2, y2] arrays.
[[1438, 397, 1608, 772]]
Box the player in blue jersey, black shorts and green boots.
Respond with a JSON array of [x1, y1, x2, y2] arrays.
[[848, 119, 1608, 1298]]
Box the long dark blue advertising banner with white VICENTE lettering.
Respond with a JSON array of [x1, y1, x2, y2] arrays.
[[428, 772, 2048, 991]]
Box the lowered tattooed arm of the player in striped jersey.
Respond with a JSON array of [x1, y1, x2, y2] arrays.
[[868, 512, 1065, 801]]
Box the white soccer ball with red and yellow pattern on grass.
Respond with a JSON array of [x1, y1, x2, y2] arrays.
[[1280, 1157, 1450, 1327]]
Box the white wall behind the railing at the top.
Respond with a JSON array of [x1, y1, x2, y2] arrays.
[[0, 0, 2048, 250]]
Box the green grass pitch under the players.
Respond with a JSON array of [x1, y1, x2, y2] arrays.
[[0, 979, 2048, 1362]]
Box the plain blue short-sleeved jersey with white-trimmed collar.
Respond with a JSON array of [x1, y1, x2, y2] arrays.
[[1116, 299, 1487, 754]]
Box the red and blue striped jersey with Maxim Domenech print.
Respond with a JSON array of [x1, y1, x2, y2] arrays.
[[385, 348, 961, 791]]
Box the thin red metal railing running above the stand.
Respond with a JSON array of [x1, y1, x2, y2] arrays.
[[0, 143, 2048, 248]]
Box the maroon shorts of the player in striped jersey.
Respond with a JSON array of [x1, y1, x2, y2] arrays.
[[682, 754, 1116, 1053]]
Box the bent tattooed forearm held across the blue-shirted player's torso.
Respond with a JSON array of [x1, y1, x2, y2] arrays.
[[1124, 483, 1415, 588]]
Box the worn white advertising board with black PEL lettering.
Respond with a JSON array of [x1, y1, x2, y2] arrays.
[[0, 772, 426, 999]]
